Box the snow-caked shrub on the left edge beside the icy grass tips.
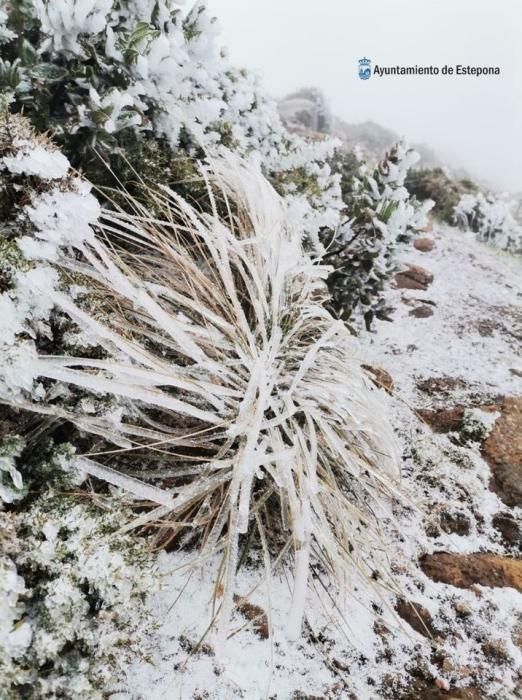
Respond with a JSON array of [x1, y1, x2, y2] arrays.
[[0, 110, 99, 410]]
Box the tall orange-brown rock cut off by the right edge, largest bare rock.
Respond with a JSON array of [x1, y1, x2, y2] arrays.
[[482, 396, 522, 506]]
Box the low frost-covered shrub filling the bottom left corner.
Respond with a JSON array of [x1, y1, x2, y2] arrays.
[[0, 492, 158, 700]]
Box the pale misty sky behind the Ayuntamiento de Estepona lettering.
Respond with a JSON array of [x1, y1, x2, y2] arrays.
[[207, 0, 522, 191]]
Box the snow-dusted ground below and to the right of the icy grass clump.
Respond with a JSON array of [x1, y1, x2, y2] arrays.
[[112, 228, 522, 700]]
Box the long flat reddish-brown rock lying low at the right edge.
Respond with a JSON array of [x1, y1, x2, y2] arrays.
[[420, 552, 522, 592]]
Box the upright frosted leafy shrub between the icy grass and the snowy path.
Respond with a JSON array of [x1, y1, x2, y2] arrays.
[[323, 143, 433, 329]]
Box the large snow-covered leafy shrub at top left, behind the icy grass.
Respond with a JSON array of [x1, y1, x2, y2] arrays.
[[0, 0, 342, 245]]
